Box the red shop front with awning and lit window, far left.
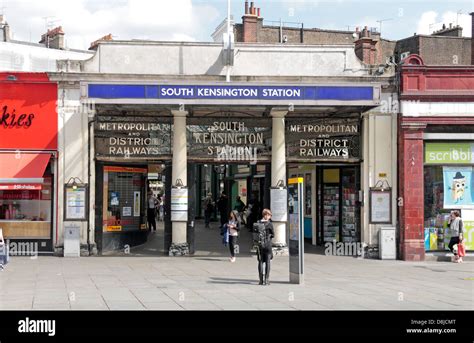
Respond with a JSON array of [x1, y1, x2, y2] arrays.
[[0, 73, 58, 255]]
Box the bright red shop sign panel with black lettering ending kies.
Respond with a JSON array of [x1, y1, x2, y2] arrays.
[[0, 74, 58, 150]]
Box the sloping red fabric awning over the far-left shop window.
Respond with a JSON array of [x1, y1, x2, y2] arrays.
[[0, 152, 51, 185]]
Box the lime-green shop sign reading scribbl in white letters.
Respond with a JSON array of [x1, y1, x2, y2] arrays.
[[425, 142, 474, 164]]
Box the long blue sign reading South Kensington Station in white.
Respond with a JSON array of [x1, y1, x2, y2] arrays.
[[88, 84, 378, 101]]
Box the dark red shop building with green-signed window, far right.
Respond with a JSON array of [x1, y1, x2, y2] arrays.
[[398, 55, 474, 261]]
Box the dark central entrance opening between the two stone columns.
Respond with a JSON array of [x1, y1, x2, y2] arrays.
[[190, 163, 270, 257]]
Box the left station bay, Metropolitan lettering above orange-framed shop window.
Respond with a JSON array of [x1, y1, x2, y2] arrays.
[[94, 113, 171, 253]]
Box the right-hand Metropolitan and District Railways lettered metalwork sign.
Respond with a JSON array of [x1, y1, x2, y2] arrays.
[[286, 118, 360, 161]]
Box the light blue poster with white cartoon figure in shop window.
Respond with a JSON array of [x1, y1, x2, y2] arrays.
[[443, 167, 474, 209]]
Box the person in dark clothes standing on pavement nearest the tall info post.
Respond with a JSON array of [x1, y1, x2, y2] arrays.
[[254, 208, 275, 285]]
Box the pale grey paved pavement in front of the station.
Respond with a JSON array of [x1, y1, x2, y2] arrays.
[[0, 224, 474, 310]]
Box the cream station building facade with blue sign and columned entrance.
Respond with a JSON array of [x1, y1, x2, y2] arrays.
[[50, 41, 397, 254]]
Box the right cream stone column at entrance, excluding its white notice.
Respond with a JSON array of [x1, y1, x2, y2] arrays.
[[270, 109, 288, 255]]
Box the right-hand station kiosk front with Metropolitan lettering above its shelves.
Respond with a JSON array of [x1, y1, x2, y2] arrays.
[[286, 117, 361, 245]]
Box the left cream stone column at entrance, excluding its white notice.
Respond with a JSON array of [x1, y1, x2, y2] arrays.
[[166, 110, 189, 256]]
